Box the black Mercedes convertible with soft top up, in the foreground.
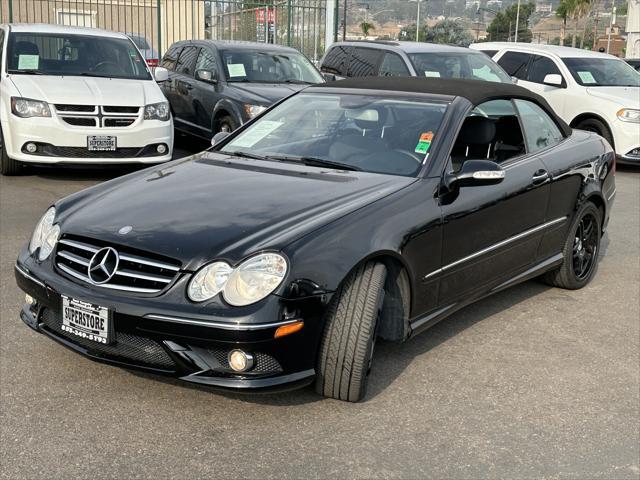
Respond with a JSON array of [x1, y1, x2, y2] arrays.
[[15, 78, 615, 401]]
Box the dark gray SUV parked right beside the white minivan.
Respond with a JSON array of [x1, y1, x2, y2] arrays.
[[160, 40, 324, 139]]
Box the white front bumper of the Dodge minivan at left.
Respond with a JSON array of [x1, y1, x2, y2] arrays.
[[2, 114, 173, 165]]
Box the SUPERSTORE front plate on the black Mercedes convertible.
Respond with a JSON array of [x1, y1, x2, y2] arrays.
[[62, 295, 111, 345]]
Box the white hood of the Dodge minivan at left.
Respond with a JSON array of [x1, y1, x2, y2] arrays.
[[11, 75, 164, 106]]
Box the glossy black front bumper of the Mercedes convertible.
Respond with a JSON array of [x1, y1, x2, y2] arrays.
[[15, 261, 321, 392]]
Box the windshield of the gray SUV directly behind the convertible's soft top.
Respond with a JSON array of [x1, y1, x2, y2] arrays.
[[408, 52, 512, 83]]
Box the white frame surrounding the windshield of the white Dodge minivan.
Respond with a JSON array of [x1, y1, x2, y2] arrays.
[[5, 30, 153, 81]]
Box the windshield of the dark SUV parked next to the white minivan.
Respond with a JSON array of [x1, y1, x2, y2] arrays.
[[220, 49, 322, 83]]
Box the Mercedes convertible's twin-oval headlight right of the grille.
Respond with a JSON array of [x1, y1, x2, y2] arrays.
[[187, 253, 287, 307]]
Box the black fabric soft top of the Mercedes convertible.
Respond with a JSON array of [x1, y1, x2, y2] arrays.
[[314, 77, 571, 136]]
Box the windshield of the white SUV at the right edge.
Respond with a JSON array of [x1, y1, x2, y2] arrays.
[[563, 57, 640, 87]]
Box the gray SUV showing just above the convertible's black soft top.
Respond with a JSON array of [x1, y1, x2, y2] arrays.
[[320, 41, 512, 83]]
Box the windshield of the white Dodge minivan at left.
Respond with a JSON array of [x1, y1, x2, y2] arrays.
[[7, 33, 151, 80]]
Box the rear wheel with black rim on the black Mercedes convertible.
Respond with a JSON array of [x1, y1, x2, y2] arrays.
[[543, 202, 602, 290]]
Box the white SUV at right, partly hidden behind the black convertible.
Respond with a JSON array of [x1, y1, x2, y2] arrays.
[[471, 42, 640, 165]]
